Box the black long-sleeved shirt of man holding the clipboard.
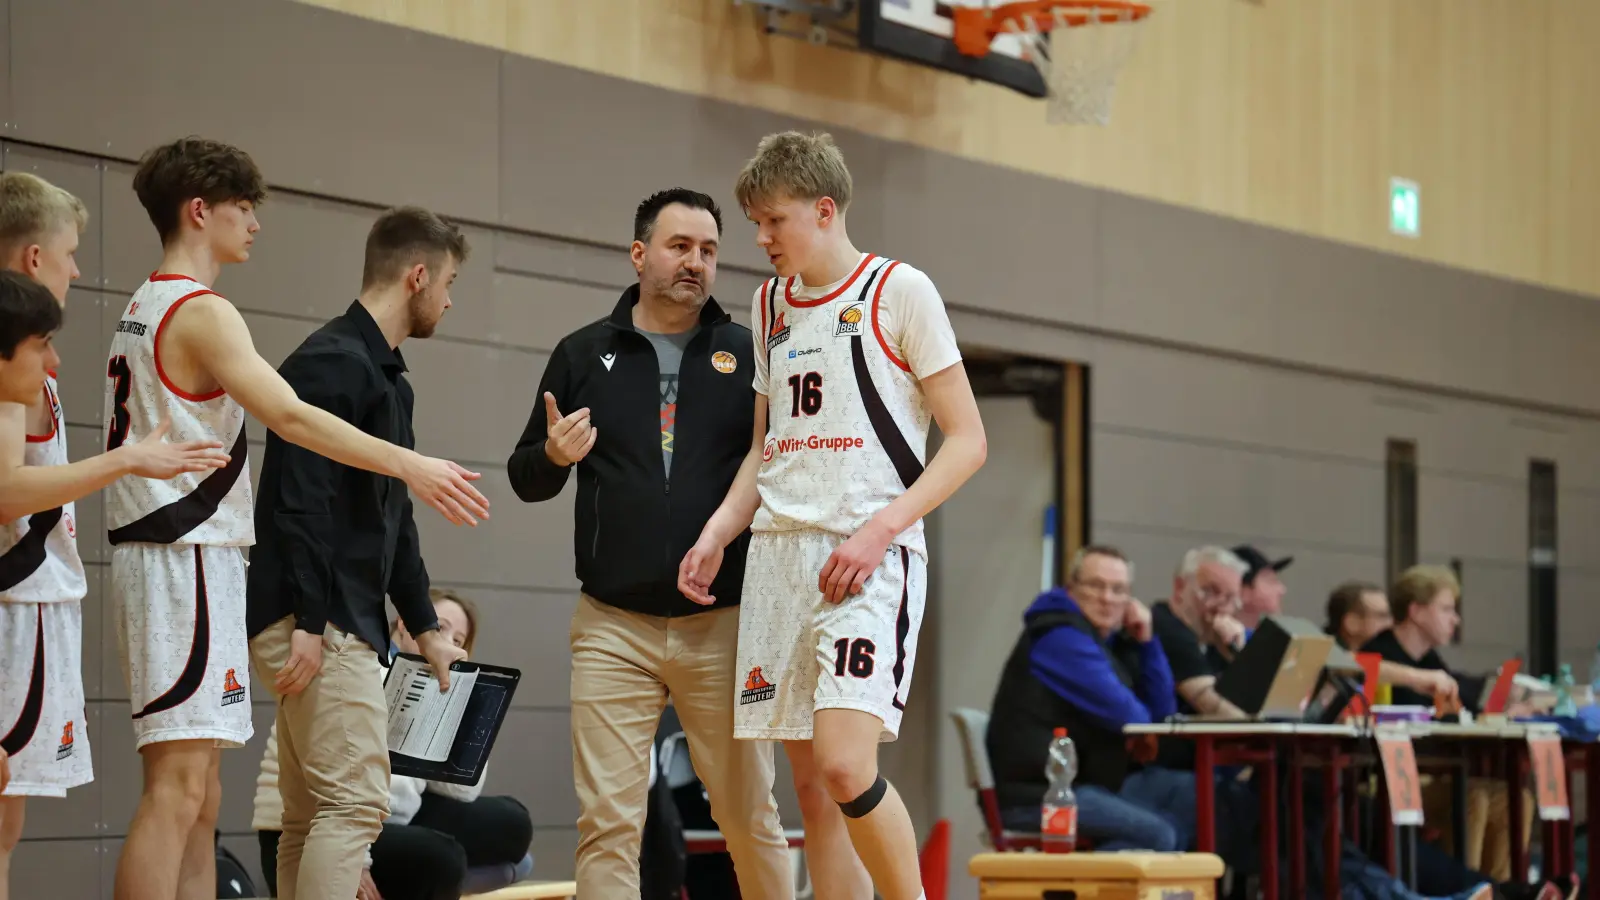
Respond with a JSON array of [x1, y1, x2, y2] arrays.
[[245, 301, 438, 661]]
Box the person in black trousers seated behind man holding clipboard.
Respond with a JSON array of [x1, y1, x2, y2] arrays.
[[253, 588, 533, 900]]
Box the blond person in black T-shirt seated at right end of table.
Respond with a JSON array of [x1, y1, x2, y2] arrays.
[[1362, 565, 1533, 881]]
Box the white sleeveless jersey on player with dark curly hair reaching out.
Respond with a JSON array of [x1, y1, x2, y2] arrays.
[[106, 275, 256, 546]]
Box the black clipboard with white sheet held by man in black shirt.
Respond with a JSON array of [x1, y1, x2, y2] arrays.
[[384, 653, 522, 785]]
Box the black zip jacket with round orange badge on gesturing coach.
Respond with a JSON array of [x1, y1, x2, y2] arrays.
[[506, 285, 755, 617]]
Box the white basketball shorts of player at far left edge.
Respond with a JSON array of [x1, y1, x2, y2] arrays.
[[0, 601, 94, 798]]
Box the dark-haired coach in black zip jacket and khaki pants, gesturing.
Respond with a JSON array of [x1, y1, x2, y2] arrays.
[[507, 189, 794, 900]]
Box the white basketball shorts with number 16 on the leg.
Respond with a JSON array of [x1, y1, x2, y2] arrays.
[[733, 530, 928, 741]]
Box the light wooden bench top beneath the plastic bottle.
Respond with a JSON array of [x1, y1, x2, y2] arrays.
[[966, 854, 1222, 900]]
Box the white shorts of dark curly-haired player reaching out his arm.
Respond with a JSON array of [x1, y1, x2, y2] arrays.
[[110, 543, 254, 748]]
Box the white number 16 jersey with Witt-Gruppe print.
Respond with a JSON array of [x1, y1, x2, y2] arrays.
[[750, 253, 962, 556]]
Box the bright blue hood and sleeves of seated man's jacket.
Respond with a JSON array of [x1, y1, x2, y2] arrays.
[[1022, 588, 1178, 730]]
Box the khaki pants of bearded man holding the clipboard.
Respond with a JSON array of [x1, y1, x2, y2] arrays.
[[250, 618, 389, 900]]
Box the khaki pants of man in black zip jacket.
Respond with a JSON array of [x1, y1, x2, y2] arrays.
[[573, 596, 794, 900]]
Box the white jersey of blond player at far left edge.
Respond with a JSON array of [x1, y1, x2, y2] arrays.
[[0, 376, 88, 604]]
